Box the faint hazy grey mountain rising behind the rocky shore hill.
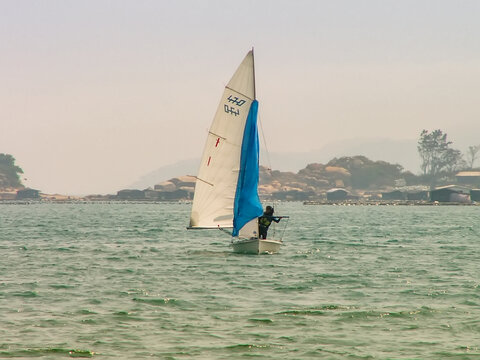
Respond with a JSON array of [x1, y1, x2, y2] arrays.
[[128, 139, 420, 190]]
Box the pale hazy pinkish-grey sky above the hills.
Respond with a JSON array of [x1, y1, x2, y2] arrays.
[[0, 0, 480, 195]]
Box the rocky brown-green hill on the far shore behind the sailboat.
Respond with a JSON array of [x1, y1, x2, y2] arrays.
[[123, 156, 419, 201]]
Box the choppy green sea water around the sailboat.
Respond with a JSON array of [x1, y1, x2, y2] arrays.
[[0, 203, 480, 359]]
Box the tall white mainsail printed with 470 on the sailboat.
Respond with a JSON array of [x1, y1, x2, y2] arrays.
[[190, 51, 256, 228]]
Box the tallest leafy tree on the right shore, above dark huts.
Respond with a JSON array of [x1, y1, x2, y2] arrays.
[[417, 129, 465, 182]]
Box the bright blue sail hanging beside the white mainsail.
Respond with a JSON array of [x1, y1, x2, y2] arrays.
[[232, 100, 263, 236]]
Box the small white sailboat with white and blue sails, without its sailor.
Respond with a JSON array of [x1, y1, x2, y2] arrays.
[[188, 49, 282, 254]]
